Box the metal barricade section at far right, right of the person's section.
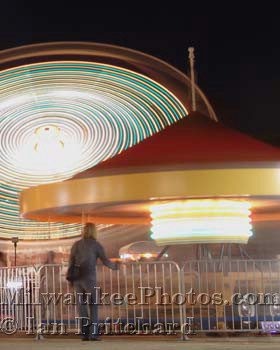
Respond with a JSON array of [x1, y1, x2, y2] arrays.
[[182, 259, 280, 332]]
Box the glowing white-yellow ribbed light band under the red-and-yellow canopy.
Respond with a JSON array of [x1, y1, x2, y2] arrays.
[[150, 200, 252, 245]]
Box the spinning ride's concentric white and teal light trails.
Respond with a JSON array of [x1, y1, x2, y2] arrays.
[[0, 60, 187, 239]]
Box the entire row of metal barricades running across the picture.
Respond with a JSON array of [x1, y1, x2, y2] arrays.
[[0, 259, 280, 335]]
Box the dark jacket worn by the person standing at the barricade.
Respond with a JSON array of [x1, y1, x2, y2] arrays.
[[69, 238, 118, 283]]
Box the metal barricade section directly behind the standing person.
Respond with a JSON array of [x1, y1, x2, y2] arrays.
[[38, 262, 182, 334]]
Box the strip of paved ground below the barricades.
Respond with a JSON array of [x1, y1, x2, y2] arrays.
[[0, 337, 280, 350]]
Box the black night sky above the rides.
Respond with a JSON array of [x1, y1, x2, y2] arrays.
[[0, 6, 280, 146]]
